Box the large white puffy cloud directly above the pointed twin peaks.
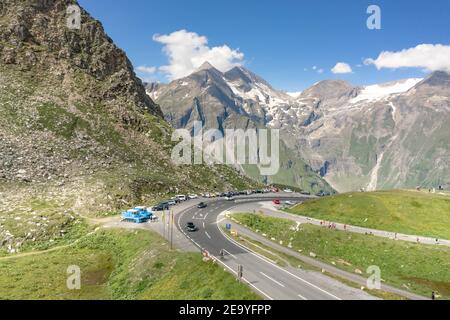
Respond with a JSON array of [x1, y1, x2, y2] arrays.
[[153, 30, 244, 80]]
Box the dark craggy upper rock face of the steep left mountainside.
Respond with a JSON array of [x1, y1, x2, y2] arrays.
[[0, 0, 161, 115]]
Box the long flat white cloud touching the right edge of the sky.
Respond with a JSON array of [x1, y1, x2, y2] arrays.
[[365, 44, 450, 72]]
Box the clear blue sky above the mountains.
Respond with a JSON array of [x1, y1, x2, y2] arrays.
[[79, 0, 450, 91]]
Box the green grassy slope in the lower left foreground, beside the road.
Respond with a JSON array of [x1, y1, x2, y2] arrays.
[[0, 230, 259, 299]]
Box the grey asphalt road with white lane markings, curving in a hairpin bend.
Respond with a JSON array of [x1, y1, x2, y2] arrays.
[[177, 196, 374, 300]]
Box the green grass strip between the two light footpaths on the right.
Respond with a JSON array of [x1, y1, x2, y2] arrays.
[[234, 214, 450, 299]]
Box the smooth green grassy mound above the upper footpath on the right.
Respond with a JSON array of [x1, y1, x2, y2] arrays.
[[289, 191, 450, 239]]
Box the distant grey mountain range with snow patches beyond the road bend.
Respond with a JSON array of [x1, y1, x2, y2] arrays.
[[146, 62, 450, 192]]
